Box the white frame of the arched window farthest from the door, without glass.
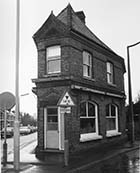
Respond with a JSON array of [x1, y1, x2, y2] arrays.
[[106, 104, 119, 136]]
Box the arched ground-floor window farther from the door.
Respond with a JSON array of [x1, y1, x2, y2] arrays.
[[106, 104, 118, 135]]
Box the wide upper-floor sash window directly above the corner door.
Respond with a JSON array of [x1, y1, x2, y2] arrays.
[[46, 46, 61, 74]]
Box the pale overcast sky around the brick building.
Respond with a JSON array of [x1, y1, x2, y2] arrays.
[[0, 0, 140, 115]]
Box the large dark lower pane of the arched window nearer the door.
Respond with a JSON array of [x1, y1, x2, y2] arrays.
[[80, 118, 96, 134]]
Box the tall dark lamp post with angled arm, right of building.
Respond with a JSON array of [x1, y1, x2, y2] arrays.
[[127, 42, 140, 146]]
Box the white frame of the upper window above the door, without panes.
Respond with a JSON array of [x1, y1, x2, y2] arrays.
[[46, 45, 61, 75]]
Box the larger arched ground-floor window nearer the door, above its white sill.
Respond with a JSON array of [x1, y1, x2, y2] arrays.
[[80, 101, 98, 134]]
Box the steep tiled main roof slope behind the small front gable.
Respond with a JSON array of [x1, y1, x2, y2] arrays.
[[57, 4, 113, 52]]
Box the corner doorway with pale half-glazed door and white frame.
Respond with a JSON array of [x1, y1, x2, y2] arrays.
[[44, 106, 64, 150]]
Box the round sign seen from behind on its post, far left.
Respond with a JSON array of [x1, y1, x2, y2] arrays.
[[0, 92, 15, 166]]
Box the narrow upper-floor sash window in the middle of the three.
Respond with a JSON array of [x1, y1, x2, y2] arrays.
[[83, 51, 92, 78]]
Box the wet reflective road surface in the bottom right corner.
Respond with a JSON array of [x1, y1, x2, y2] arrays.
[[83, 149, 140, 173]]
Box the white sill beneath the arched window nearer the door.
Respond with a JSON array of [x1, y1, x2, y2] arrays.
[[80, 133, 103, 142]]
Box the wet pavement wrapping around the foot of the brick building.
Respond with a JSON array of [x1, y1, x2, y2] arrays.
[[1, 141, 140, 173]]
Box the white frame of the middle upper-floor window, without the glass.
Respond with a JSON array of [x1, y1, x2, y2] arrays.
[[82, 51, 93, 79]]
